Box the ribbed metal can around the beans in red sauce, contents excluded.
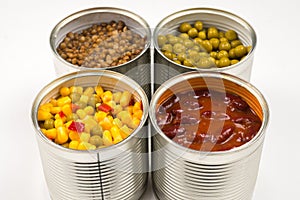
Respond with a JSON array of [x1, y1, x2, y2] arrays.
[[149, 72, 269, 200]]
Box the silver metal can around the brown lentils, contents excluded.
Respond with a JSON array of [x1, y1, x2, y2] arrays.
[[50, 7, 151, 98]]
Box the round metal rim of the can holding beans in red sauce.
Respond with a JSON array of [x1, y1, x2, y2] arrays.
[[149, 71, 270, 156]]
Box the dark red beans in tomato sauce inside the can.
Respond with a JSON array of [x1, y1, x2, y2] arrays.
[[156, 89, 262, 151]]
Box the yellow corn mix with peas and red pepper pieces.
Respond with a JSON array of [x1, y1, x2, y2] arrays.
[[37, 85, 143, 150]]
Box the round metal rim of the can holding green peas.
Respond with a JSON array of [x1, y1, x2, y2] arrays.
[[153, 7, 257, 72]]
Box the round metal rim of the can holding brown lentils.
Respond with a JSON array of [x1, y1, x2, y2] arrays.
[[49, 7, 151, 71]]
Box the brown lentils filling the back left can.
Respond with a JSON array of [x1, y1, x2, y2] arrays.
[[56, 21, 146, 68]]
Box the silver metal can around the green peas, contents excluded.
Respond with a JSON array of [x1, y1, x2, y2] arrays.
[[153, 8, 256, 89]]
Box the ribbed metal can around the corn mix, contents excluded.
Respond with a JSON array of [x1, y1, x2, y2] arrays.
[[31, 70, 148, 200]]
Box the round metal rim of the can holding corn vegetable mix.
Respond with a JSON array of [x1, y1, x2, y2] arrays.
[[31, 70, 149, 154]]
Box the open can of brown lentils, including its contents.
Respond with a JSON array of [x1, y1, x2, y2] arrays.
[[50, 7, 151, 97]]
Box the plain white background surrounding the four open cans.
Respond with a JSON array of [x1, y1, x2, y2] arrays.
[[0, 0, 300, 200]]
